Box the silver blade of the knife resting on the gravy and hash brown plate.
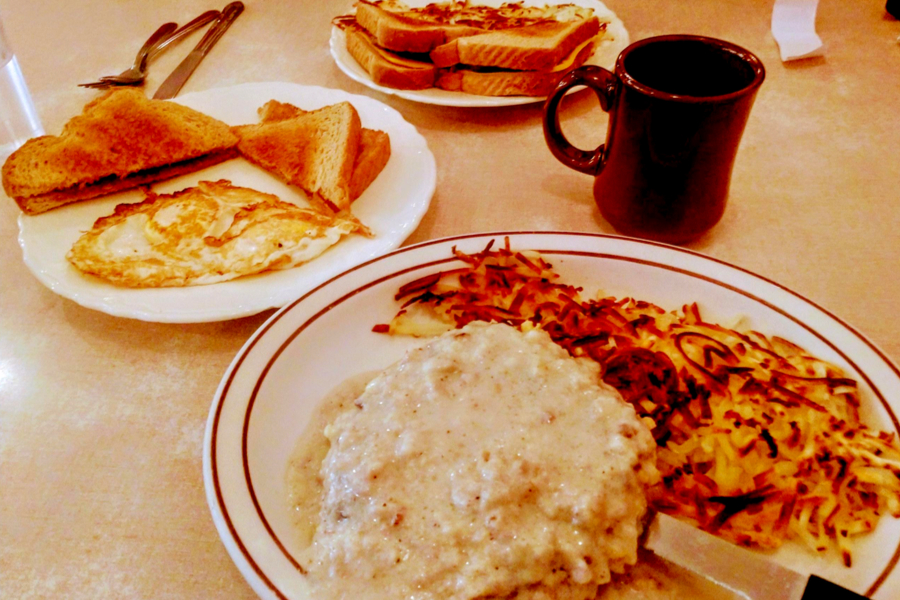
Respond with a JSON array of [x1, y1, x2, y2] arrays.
[[644, 513, 865, 600]]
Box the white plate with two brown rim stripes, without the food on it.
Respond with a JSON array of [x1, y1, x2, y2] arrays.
[[203, 232, 900, 600]]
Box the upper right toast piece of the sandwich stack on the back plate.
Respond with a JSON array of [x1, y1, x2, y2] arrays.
[[431, 17, 600, 71]]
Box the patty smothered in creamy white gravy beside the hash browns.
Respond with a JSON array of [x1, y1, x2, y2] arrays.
[[304, 323, 658, 600]]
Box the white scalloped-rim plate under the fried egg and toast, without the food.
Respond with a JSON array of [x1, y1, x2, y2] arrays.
[[19, 83, 437, 323]]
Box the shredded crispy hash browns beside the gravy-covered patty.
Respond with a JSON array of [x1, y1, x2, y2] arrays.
[[373, 239, 900, 566]]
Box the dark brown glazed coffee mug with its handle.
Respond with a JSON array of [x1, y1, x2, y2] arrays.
[[544, 35, 766, 243]]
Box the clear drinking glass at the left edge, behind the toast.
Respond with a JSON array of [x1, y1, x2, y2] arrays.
[[0, 13, 44, 160]]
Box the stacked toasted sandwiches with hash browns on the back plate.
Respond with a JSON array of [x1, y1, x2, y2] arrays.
[[335, 0, 606, 96]]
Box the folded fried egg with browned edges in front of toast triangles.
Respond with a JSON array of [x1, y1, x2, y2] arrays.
[[66, 180, 368, 287]]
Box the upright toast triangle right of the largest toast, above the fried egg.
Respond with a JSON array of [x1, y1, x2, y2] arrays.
[[233, 102, 362, 211]]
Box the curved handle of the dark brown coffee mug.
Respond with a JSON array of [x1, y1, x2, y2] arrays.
[[544, 65, 617, 175]]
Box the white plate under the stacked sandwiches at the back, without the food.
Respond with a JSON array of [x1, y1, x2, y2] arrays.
[[331, 0, 629, 107]]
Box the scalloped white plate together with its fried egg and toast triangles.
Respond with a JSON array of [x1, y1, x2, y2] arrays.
[[3, 83, 436, 322]]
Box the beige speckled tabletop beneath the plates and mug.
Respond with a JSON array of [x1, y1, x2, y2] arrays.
[[0, 0, 900, 598]]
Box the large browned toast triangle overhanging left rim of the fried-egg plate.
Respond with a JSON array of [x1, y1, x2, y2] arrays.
[[2, 88, 238, 214]]
